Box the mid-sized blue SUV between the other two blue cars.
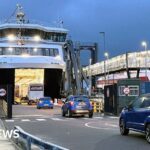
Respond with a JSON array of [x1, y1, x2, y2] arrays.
[[62, 95, 93, 118]]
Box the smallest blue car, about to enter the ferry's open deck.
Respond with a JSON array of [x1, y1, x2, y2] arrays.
[[37, 97, 54, 109]]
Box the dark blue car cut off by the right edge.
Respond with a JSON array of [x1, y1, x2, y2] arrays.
[[119, 94, 150, 143]]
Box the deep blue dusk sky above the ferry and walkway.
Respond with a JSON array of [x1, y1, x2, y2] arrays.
[[0, 0, 150, 63]]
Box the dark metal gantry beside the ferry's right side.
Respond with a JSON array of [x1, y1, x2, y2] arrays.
[[64, 40, 97, 95]]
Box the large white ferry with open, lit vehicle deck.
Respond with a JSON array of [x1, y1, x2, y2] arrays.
[[0, 5, 68, 101]]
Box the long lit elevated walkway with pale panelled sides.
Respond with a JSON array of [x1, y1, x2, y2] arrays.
[[83, 50, 150, 78]]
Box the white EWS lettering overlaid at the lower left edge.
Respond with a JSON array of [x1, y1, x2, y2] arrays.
[[0, 129, 19, 139]]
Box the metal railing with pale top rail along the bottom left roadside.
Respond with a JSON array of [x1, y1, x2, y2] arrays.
[[13, 126, 68, 150]]
